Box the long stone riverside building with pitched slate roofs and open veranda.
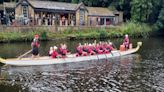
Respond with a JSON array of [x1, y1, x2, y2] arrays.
[[1, 0, 123, 26]]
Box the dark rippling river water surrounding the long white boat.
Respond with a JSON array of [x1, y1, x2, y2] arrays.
[[0, 38, 164, 92]]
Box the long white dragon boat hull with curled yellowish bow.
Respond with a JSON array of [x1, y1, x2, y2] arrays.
[[0, 42, 142, 66]]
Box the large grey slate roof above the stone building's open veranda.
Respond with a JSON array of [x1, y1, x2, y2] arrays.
[[29, 0, 78, 10]]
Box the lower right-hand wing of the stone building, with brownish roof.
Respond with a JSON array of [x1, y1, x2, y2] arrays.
[[87, 7, 123, 26]]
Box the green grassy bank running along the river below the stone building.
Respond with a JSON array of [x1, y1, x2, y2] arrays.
[[0, 22, 152, 42]]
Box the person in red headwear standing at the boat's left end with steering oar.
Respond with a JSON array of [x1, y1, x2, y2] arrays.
[[31, 34, 40, 58]]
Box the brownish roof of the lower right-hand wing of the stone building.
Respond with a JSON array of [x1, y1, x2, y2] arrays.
[[87, 7, 115, 16]]
